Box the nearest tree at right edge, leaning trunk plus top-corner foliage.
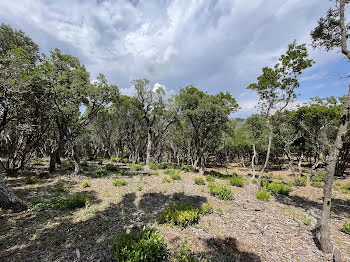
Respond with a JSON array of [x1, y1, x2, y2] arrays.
[[311, 0, 350, 253]]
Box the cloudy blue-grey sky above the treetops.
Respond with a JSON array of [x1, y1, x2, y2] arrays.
[[0, 0, 349, 117]]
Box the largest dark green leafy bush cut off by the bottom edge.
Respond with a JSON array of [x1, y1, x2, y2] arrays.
[[111, 227, 169, 262]]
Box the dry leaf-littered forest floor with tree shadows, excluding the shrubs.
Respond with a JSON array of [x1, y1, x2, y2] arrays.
[[0, 162, 350, 262]]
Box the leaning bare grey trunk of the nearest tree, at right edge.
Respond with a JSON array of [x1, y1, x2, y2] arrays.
[[320, 85, 350, 253]]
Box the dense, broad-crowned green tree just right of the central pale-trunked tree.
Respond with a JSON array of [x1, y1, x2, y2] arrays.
[[175, 85, 238, 174]]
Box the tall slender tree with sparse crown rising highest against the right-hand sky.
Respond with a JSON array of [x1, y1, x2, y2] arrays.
[[248, 42, 313, 190]]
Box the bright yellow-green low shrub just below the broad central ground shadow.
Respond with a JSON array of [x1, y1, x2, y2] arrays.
[[158, 204, 200, 227]]
